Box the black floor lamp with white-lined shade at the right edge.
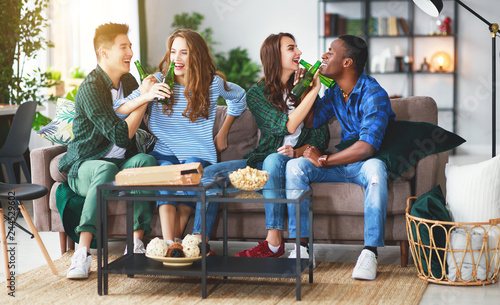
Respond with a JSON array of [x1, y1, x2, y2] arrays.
[[413, 0, 499, 157]]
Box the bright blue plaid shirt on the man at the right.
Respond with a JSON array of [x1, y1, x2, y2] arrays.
[[314, 72, 396, 151]]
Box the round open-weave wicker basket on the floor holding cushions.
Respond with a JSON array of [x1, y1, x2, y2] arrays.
[[406, 197, 500, 286]]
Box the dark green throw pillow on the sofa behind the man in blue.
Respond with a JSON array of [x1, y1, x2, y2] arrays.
[[335, 121, 465, 179]]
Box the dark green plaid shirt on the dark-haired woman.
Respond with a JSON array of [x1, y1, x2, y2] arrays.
[[244, 82, 330, 167]]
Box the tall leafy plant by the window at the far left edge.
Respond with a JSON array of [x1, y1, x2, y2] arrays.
[[0, 0, 53, 144]]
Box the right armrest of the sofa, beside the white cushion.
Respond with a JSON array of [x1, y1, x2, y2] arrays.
[[415, 151, 449, 197]]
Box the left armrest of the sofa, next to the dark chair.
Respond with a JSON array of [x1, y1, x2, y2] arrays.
[[30, 145, 66, 232]]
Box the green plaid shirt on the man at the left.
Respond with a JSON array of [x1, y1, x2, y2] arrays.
[[59, 65, 139, 177]]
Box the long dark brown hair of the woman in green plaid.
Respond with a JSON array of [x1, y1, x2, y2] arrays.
[[259, 33, 300, 112]]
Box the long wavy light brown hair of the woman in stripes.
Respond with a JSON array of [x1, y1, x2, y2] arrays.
[[158, 29, 231, 122]]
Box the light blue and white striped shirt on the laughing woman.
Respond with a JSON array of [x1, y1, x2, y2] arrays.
[[148, 72, 246, 164]]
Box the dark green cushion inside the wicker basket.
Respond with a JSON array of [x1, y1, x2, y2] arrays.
[[410, 185, 451, 279]]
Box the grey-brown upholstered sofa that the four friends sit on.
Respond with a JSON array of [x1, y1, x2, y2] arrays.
[[31, 97, 448, 266]]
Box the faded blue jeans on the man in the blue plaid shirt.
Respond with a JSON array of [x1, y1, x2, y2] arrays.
[[286, 158, 387, 247]]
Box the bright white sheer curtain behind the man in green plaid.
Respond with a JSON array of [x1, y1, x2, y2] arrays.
[[47, 0, 140, 79]]
